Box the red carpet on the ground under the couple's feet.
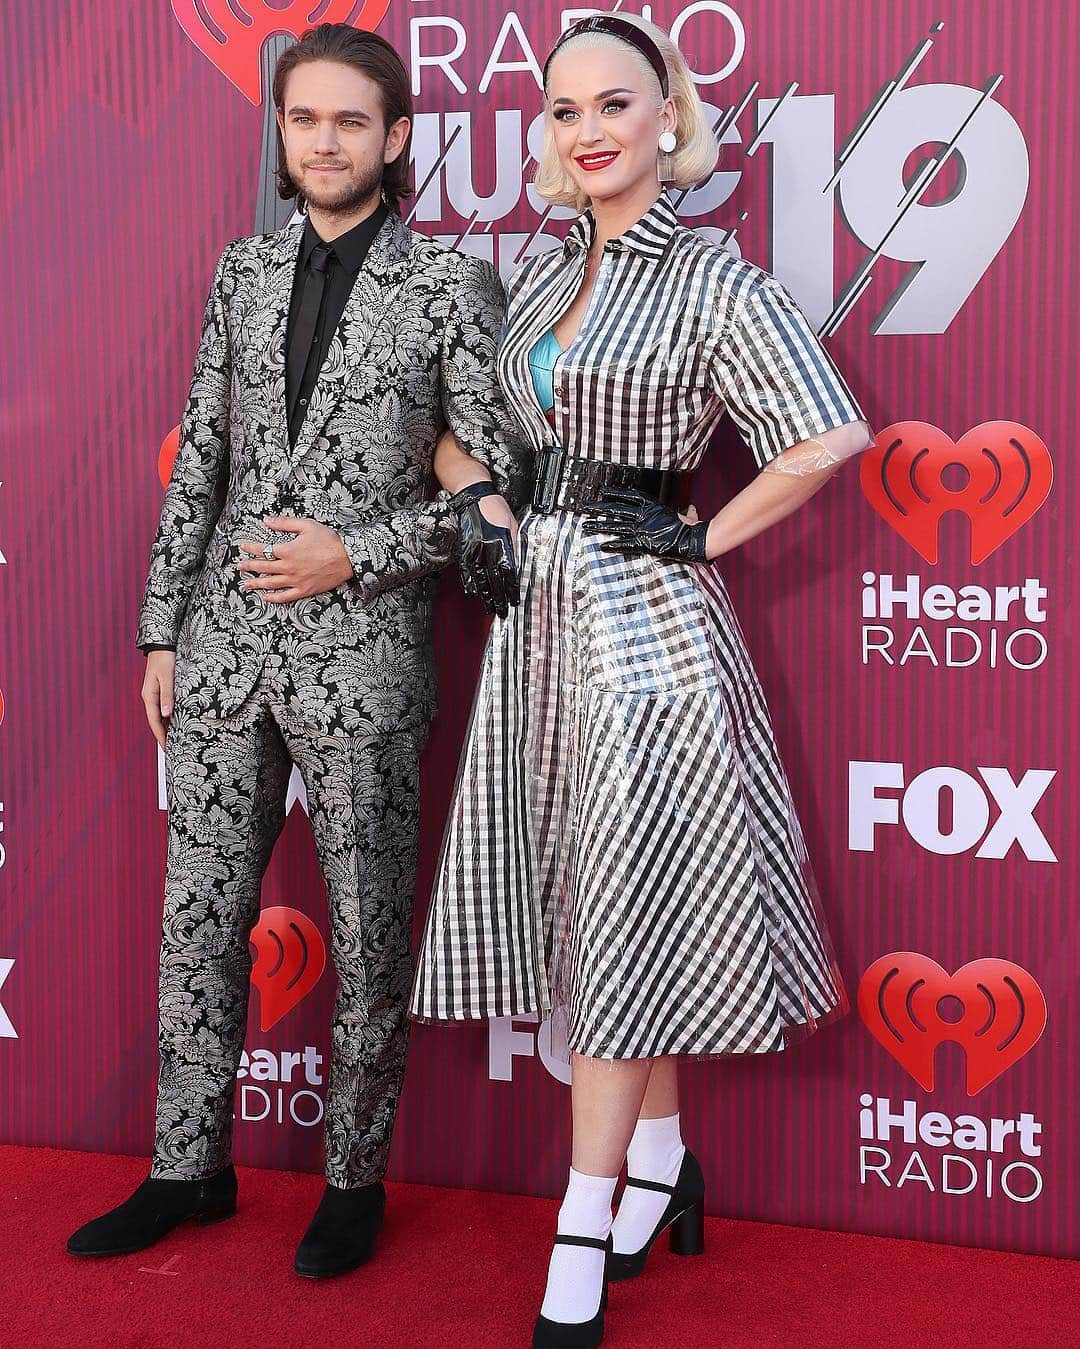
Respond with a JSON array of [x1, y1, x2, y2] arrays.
[[8, 1148, 1080, 1349]]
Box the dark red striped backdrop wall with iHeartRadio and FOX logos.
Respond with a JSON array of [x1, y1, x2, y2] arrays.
[[0, 0, 1080, 1255]]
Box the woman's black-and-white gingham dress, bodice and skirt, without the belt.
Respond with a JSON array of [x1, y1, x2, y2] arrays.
[[411, 197, 863, 1059]]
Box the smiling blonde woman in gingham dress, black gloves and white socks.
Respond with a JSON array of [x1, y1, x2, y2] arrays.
[[413, 16, 870, 1346]]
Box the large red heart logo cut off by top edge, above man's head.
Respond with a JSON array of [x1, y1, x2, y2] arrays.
[[173, 0, 390, 108]]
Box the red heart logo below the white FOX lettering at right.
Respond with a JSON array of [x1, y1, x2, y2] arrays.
[[859, 951, 1046, 1095]]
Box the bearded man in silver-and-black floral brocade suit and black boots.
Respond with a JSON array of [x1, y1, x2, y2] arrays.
[[67, 24, 516, 1278]]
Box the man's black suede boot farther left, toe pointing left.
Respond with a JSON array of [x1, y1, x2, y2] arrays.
[[67, 1167, 236, 1256]]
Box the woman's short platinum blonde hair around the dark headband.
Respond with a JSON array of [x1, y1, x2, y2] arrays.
[[533, 13, 719, 210]]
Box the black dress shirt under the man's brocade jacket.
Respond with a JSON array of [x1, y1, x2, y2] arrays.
[[139, 204, 387, 654]]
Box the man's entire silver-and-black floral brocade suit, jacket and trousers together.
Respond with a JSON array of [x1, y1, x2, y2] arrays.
[[138, 217, 527, 1187]]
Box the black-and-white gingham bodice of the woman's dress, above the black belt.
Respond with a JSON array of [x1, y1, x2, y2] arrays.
[[499, 197, 863, 468]]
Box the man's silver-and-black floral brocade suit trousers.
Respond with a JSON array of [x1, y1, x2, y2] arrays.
[[151, 658, 423, 1187]]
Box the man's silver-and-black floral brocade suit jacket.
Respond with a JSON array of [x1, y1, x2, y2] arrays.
[[138, 216, 526, 731]]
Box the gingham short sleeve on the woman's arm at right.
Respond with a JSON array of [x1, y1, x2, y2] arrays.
[[712, 277, 866, 468]]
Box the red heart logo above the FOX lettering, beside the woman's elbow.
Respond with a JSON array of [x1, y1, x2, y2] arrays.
[[859, 421, 1053, 567]]
